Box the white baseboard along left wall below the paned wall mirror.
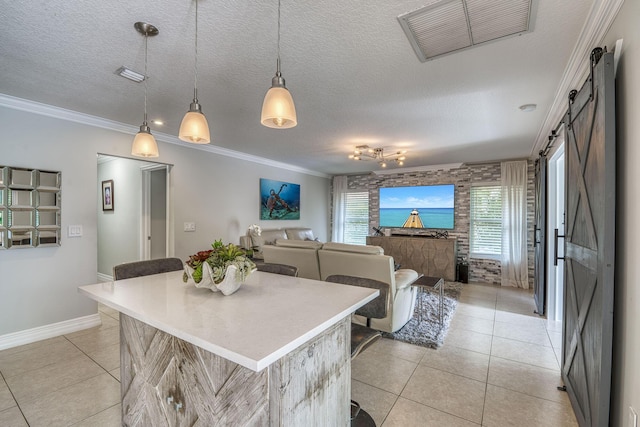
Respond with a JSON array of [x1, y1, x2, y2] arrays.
[[0, 313, 102, 350]]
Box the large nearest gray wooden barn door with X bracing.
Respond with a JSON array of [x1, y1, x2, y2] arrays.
[[562, 50, 616, 426]]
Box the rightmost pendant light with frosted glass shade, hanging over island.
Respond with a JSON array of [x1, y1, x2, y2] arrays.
[[260, 0, 298, 129]]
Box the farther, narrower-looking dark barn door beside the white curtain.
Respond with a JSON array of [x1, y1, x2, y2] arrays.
[[533, 153, 547, 316]]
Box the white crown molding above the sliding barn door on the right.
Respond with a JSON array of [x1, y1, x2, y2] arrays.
[[529, 0, 624, 158]]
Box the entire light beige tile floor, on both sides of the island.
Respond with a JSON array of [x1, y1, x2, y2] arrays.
[[0, 284, 577, 427]]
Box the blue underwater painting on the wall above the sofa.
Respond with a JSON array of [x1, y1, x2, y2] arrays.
[[260, 178, 300, 220]]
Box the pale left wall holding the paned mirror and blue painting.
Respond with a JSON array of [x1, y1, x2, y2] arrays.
[[0, 106, 330, 339]]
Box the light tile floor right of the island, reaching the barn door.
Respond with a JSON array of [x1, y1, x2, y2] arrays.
[[351, 284, 578, 427]]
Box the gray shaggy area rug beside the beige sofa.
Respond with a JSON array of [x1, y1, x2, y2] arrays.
[[382, 282, 463, 348]]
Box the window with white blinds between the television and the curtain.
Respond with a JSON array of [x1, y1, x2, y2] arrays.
[[469, 185, 502, 258]]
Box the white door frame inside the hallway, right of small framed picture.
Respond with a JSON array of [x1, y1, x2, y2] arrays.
[[140, 164, 174, 260]]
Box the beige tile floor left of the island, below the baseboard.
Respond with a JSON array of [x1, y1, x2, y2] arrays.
[[0, 306, 121, 427]]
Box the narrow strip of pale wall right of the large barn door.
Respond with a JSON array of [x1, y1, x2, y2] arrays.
[[604, 0, 640, 427]]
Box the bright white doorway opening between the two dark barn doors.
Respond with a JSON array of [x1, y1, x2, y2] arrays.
[[547, 139, 565, 322]]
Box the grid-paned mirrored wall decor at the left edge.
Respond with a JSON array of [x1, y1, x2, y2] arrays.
[[0, 166, 62, 249]]
